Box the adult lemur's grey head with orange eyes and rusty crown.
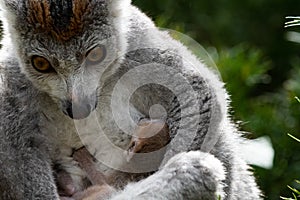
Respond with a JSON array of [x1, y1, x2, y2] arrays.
[[1, 0, 130, 119]]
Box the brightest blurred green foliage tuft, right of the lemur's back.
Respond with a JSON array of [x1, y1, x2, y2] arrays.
[[215, 44, 271, 106]]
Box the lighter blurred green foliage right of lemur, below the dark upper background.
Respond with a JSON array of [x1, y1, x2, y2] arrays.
[[216, 44, 300, 199]]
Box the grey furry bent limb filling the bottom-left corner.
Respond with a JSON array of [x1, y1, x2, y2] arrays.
[[0, 140, 59, 200]]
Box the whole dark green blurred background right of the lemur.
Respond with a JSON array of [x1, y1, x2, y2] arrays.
[[133, 0, 300, 199]]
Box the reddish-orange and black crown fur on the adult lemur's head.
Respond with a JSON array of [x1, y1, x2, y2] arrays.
[[27, 0, 90, 41]]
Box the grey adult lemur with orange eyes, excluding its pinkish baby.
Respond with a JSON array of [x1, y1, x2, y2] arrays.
[[0, 0, 260, 200]]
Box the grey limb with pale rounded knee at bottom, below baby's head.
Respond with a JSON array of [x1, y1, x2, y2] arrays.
[[111, 151, 225, 200]]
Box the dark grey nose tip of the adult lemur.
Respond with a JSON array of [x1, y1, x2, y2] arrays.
[[64, 101, 93, 119]]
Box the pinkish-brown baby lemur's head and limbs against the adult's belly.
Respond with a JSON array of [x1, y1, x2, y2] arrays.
[[57, 119, 170, 200]]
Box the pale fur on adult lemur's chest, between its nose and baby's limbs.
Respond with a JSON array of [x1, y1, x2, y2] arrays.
[[42, 99, 137, 190]]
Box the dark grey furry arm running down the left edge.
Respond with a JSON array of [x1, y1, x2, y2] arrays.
[[0, 66, 59, 200]]
